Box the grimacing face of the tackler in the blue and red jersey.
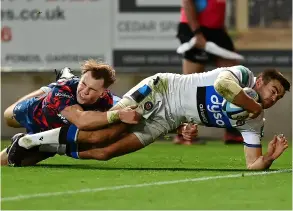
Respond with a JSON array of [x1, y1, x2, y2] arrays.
[[77, 72, 106, 105]]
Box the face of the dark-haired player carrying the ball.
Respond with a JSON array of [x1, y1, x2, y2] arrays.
[[256, 78, 285, 109]]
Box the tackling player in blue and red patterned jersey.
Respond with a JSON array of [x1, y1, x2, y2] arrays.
[[1, 60, 138, 165]]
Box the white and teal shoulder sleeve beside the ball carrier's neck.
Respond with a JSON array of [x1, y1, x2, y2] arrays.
[[226, 65, 254, 88]]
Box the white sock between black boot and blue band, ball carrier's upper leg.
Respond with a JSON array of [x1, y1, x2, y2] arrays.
[[18, 128, 61, 149]]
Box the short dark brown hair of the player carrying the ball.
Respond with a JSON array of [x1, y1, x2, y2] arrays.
[[258, 69, 291, 91]]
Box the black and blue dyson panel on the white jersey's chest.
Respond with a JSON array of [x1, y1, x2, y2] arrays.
[[197, 86, 231, 127]]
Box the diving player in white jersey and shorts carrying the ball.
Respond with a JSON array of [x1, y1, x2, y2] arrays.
[[9, 66, 290, 169]]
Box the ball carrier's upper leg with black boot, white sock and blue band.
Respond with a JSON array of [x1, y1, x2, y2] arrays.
[[8, 123, 126, 166]]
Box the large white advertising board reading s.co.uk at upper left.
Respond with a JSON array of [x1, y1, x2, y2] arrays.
[[1, 0, 112, 71]]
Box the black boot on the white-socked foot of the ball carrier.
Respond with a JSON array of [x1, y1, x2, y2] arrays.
[[8, 133, 28, 167]]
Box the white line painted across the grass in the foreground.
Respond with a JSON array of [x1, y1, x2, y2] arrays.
[[1, 169, 292, 202]]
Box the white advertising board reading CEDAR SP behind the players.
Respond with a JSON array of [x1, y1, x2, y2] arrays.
[[114, 0, 181, 50]]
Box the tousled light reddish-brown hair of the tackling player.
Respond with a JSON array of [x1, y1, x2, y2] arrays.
[[81, 59, 116, 88]]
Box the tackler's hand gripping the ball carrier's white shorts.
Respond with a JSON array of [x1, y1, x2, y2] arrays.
[[118, 106, 141, 124]]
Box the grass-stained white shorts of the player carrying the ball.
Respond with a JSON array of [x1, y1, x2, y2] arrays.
[[123, 74, 179, 146]]
